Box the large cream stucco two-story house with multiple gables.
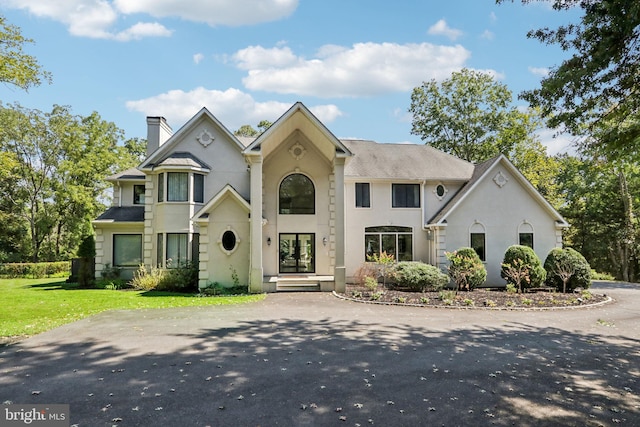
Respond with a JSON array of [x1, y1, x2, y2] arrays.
[[93, 103, 568, 292]]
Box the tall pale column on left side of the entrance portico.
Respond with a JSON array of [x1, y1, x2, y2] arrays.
[[249, 156, 263, 293]]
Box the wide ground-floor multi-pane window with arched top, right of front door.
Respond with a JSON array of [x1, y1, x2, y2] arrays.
[[364, 226, 413, 261]]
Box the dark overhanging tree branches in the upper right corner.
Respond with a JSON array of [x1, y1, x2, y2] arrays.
[[497, 0, 640, 156]]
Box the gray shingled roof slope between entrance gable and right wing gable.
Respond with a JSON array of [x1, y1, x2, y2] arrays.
[[342, 139, 474, 181]]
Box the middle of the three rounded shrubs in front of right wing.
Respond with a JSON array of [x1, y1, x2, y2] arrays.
[[500, 245, 547, 292]]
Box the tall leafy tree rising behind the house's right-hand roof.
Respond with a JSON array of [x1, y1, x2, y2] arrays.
[[409, 69, 539, 163]]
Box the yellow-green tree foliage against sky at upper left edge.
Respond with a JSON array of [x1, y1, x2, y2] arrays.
[[0, 16, 51, 90]]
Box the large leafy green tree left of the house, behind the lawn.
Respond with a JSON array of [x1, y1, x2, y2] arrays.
[[0, 105, 130, 262]]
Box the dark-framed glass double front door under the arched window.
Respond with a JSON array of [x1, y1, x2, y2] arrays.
[[280, 233, 316, 273]]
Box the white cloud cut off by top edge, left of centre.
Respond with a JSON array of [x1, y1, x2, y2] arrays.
[[114, 0, 298, 26]]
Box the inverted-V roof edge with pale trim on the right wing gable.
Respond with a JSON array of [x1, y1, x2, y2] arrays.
[[427, 154, 569, 227]]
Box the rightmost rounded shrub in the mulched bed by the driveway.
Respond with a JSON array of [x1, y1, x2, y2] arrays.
[[544, 248, 591, 292]]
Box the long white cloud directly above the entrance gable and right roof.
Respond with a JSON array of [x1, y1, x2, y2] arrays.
[[232, 43, 470, 97]]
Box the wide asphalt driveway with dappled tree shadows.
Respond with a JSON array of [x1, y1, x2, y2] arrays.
[[0, 282, 640, 427]]
